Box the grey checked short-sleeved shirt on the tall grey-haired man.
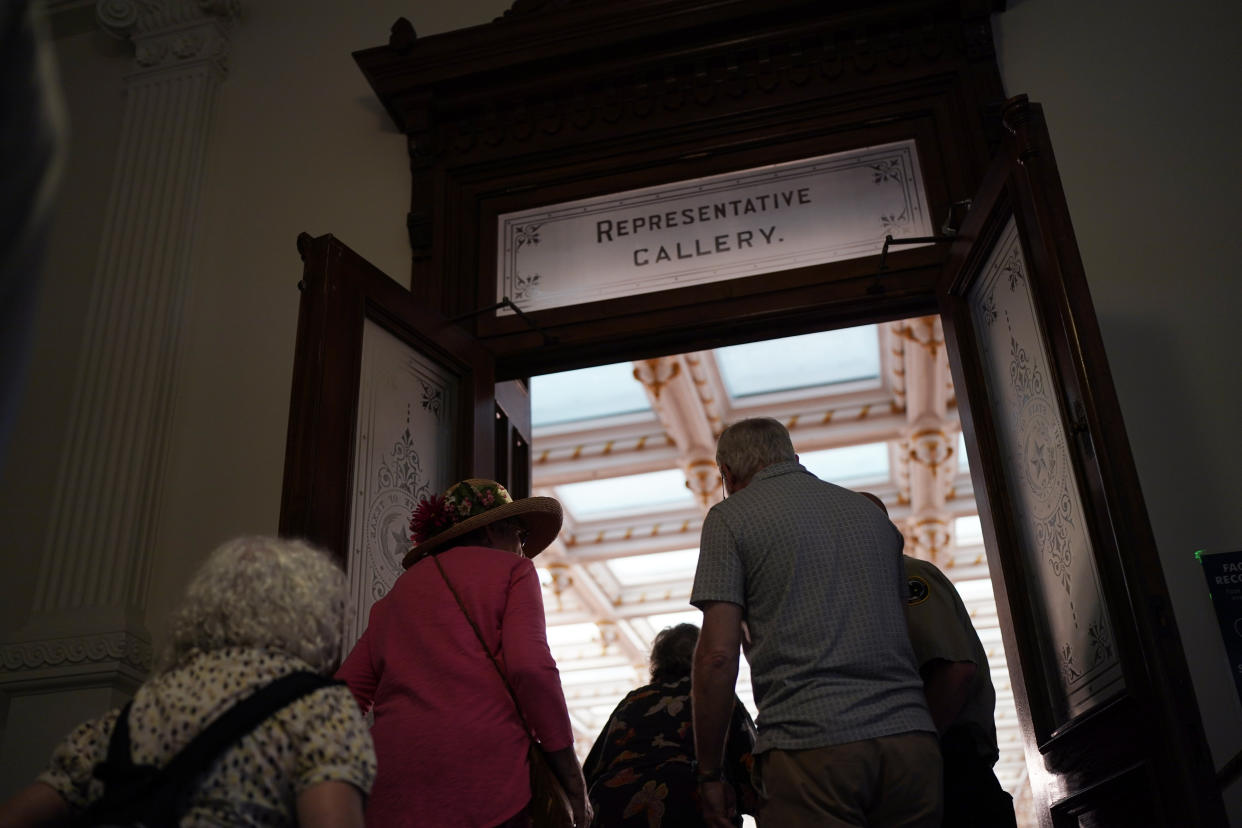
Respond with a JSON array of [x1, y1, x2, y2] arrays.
[[691, 463, 935, 752]]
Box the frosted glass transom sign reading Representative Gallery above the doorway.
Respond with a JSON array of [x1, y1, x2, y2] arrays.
[[497, 139, 932, 313]]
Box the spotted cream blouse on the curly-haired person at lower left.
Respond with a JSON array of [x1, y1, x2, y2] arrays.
[[39, 648, 375, 828]]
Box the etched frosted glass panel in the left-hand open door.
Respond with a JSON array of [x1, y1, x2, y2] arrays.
[[345, 320, 460, 648]]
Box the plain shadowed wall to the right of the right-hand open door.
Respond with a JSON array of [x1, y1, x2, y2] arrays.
[[995, 0, 1242, 826]]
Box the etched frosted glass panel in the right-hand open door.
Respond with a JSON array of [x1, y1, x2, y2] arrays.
[[966, 217, 1124, 722]]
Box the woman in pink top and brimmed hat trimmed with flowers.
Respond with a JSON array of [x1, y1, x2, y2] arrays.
[[337, 479, 591, 828]]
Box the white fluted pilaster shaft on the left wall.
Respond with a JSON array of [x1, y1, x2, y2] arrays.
[[32, 0, 236, 620]]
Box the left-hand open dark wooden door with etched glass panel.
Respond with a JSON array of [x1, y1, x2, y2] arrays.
[[279, 233, 496, 649]]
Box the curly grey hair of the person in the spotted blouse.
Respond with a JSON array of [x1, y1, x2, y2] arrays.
[[161, 536, 345, 673]]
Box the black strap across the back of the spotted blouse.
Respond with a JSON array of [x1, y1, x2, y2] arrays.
[[92, 670, 343, 824]]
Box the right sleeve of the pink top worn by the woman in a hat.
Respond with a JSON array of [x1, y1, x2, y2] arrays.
[[502, 559, 574, 751]]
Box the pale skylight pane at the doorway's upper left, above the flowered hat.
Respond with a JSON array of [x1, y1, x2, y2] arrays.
[[530, 362, 651, 426]]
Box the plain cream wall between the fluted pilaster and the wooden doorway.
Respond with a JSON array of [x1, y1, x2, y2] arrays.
[[134, 0, 504, 655]]
